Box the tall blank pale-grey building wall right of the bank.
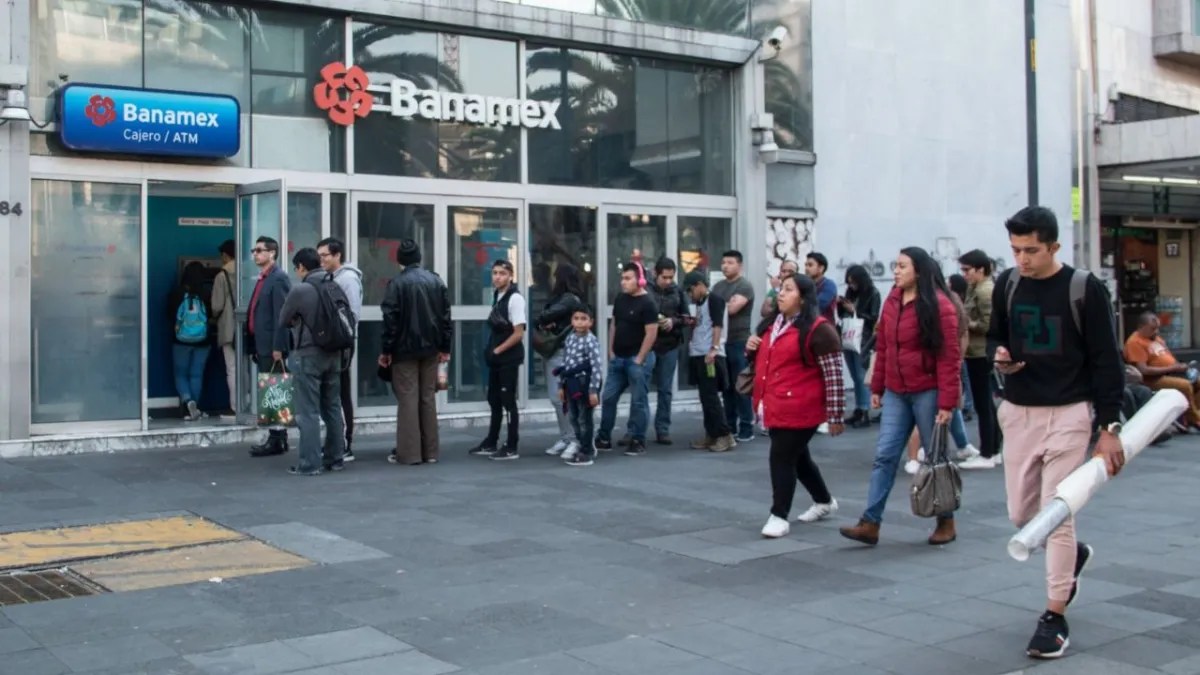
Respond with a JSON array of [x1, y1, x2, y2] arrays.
[[811, 0, 1075, 287]]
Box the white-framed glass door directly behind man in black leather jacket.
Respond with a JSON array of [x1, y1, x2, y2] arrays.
[[348, 192, 436, 417]]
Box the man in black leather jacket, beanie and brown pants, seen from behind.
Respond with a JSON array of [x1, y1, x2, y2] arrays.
[[379, 239, 454, 465]]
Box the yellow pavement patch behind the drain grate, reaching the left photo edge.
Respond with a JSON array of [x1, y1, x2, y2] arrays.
[[0, 515, 246, 569]]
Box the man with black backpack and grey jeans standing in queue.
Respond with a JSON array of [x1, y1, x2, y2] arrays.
[[280, 249, 355, 476]]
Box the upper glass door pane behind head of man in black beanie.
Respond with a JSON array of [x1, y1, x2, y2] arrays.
[[358, 202, 437, 306]]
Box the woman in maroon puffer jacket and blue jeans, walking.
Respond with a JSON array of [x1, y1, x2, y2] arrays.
[[841, 246, 961, 546]]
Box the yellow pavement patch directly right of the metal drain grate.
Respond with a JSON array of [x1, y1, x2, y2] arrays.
[[71, 539, 312, 591]]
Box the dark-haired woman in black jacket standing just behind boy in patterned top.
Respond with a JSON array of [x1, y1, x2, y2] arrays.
[[534, 263, 587, 459]]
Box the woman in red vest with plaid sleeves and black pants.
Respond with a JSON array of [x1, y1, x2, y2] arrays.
[[746, 275, 846, 537]]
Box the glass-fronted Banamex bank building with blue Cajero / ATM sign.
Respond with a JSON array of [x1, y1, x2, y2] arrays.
[[0, 0, 787, 446]]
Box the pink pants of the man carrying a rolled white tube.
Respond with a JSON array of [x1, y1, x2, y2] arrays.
[[996, 401, 1092, 602]]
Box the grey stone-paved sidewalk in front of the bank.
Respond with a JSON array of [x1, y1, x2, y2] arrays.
[[0, 416, 1200, 675]]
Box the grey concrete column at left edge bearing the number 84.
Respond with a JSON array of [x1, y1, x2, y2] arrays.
[[0, 0, 34, 440]]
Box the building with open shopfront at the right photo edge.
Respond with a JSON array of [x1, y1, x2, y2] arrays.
[[1088, 0, 1200, 348]]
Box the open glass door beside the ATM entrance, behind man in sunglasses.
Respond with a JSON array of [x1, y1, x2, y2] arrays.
[[233, 180, 290, 424]]
